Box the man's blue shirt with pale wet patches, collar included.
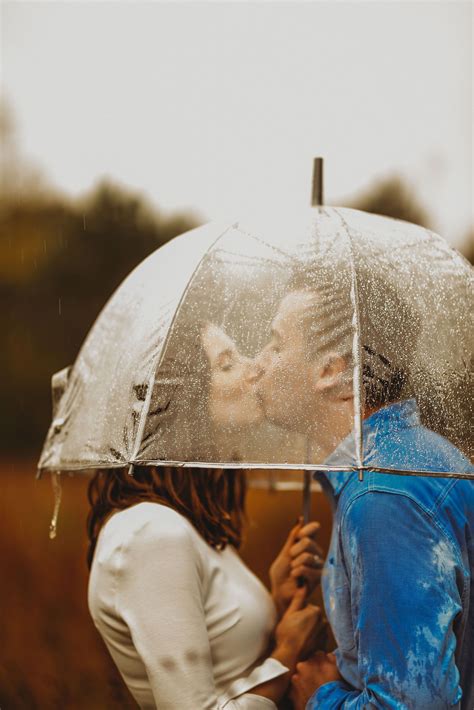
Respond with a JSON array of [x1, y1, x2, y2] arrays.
[[312, 400, 474, 710]]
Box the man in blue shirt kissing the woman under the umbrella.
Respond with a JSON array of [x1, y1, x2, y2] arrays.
[[258, 286, 474, 710]]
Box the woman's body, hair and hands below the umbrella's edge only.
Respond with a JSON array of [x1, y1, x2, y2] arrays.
[[88, 467, 319, 710]]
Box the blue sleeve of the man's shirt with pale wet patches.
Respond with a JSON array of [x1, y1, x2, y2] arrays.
[[307, 492, 462, 710]]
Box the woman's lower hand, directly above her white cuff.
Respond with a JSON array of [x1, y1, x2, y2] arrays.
[[272, 587, 321, 669]]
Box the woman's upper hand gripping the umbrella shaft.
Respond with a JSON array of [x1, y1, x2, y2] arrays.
[[270, 518, 324, 616]]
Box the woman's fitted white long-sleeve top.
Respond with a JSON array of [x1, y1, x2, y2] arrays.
[[88, 502, 288, 710]]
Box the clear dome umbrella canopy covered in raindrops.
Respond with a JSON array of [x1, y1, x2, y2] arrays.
[[39, 207, 474, 482]]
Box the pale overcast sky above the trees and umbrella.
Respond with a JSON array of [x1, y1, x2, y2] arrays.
[[2, 0, 473, 241]]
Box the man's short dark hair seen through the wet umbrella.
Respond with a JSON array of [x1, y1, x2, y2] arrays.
[[289, 262, 420, 408]]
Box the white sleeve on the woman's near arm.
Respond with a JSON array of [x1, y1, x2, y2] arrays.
[[116, 521, 286, 710]]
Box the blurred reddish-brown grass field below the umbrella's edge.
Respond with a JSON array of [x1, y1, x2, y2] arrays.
[[0, 460, 330, 710]]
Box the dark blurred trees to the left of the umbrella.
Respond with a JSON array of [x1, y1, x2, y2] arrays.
[[0, 175, 200, 453]]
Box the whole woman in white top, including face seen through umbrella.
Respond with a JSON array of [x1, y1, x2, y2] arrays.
[[88, 314, 326, 710]]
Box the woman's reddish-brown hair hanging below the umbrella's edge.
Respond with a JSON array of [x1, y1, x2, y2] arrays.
[[87, 466, 246, 568]]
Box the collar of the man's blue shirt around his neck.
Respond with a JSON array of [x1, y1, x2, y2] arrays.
[[314, 399, 420, 497]]
